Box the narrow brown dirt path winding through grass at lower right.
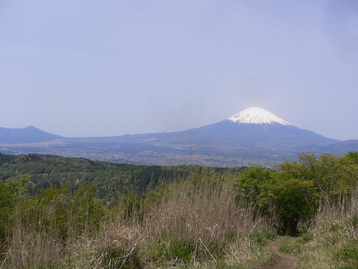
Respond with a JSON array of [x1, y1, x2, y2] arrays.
[[262, 239, 298, 269]]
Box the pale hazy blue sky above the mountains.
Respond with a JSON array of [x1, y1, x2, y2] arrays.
[[0, 0, 358, 140]]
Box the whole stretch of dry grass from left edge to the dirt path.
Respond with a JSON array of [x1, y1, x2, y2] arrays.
[[0, 176, 274, 269]]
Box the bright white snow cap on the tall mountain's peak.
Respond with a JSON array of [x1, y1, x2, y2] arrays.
[[227, 107, 290, 125]]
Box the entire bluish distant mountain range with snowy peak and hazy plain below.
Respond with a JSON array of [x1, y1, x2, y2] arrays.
[[0, 107, 358, 166]]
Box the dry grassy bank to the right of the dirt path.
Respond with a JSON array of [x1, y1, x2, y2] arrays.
[[285, 187, 358, 269]]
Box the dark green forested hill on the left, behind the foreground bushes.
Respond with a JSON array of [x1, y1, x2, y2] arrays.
[[0, 153, 243, 201]]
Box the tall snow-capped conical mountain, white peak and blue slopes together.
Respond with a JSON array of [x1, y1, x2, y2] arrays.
[[145, 107, 338, 150]]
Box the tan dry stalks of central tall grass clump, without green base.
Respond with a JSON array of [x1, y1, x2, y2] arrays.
[[145, 177, 262, 244]]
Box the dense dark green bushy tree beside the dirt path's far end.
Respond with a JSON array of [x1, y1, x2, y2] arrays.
[[238, 167, 317, 235]]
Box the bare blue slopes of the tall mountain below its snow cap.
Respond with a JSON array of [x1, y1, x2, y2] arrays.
[[143, 120, 338, 148]]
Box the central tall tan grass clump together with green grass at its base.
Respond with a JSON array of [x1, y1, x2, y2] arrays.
[[142, 178, 274, 266]]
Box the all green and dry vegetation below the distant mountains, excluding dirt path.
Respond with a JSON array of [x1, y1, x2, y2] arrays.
[[0, 152, 358, 269]]
